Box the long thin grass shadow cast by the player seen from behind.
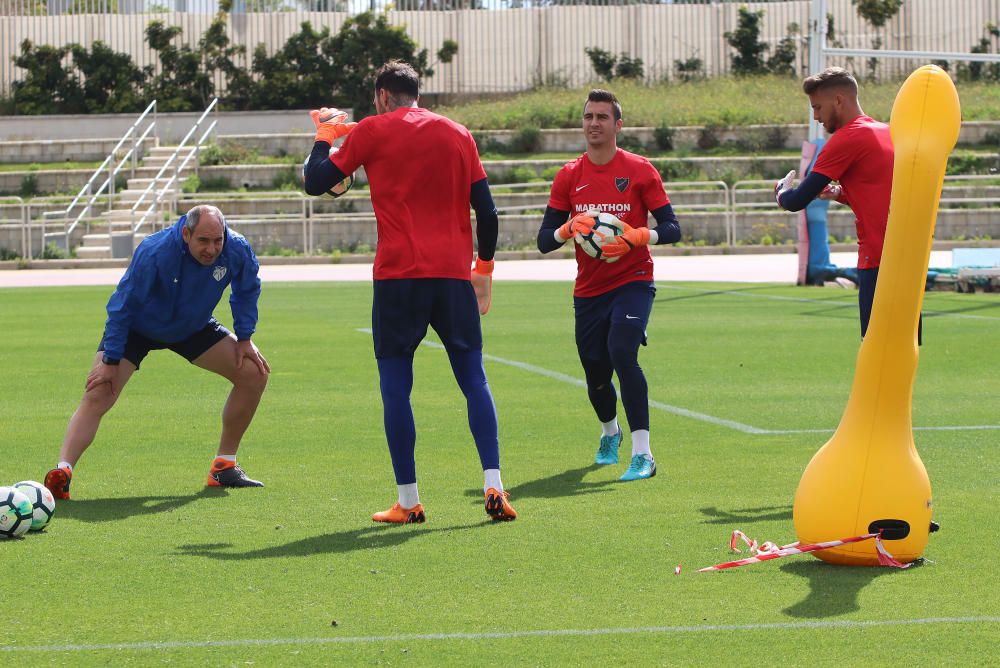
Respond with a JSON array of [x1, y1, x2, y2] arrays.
[[177, 521, 488, 561]]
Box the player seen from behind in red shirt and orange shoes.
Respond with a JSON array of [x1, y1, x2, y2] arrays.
[[305, 60, 517, 524]]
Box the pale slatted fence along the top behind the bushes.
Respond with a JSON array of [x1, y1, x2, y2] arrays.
[[0, 0, 1000, 95]]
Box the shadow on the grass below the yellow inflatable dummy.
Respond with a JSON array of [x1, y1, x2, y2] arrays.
[[781, 559, 919, 619]]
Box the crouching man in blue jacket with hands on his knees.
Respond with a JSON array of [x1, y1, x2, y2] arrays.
[[45, 204, 271, 499]]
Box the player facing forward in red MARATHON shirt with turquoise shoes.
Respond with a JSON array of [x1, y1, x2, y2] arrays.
[[538, 90, 681, 480]]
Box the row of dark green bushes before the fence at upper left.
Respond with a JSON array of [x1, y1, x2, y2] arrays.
[[11, 9, 458, 117]]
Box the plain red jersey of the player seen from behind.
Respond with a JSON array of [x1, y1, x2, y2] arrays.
[[330, 107, 486, 280]]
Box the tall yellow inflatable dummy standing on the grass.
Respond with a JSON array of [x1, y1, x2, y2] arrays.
[[793, 65, 961, 566]]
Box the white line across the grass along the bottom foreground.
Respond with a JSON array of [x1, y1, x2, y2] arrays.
[[0, 617, 1000, 653]]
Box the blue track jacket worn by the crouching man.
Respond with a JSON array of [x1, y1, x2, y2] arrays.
[[104, 216, 260, 359]]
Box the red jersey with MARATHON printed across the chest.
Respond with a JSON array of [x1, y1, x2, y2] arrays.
[[549, 149, 670, 297]]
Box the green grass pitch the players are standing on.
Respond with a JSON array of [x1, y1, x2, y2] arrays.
[[0, 283, 1000, 666]]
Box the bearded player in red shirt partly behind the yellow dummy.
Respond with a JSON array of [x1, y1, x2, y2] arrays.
[[774, 67, 894, 338]]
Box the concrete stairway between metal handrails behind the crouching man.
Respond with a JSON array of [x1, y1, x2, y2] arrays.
[[76, 146, 194, 259]]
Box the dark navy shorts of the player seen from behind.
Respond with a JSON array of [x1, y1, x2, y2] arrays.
[[372, 278, 483, 359]]
